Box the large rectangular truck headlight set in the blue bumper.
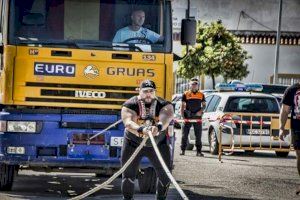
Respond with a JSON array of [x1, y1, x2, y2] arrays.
[[6, 121, 36, 133]]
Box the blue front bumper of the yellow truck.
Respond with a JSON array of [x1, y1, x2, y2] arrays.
[[0, 113, 150, 168]]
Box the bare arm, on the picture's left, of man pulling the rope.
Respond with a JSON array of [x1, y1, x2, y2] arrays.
[[121, 107, 140, 136]]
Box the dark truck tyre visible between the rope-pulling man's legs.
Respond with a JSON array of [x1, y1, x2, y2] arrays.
[[138, 167, 157, 194]]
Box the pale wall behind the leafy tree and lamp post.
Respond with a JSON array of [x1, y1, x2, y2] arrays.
[[173, 0, 300, 88]]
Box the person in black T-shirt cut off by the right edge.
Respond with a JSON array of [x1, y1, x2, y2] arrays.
[[279, 82, 300, 195]]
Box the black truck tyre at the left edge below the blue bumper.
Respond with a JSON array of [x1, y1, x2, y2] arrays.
[[0, 163, 17, 191]]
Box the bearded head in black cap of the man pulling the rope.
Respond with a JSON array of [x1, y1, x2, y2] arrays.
[[139, 80, 156, 103]]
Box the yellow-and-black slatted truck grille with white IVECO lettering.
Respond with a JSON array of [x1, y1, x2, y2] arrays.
[[25, 82, 137, 105]]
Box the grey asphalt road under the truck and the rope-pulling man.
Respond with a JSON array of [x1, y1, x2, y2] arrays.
[[0, 130, 300, 200]]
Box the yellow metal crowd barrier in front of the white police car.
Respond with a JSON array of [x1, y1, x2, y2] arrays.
[[218, 113, 292, 161]]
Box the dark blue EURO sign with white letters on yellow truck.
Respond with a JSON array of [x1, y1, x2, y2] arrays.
[[34, 62, 75, 77]]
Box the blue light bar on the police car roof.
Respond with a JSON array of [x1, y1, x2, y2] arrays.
[[216, 83, 263, 92]]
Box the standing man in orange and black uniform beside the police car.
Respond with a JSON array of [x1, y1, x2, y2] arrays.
[[180, 78, 206, 156]]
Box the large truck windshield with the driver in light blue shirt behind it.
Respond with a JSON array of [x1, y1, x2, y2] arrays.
[[9, 0, 171, 52]]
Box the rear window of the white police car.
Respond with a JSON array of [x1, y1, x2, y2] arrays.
[[224, 97, 279, 113]]
